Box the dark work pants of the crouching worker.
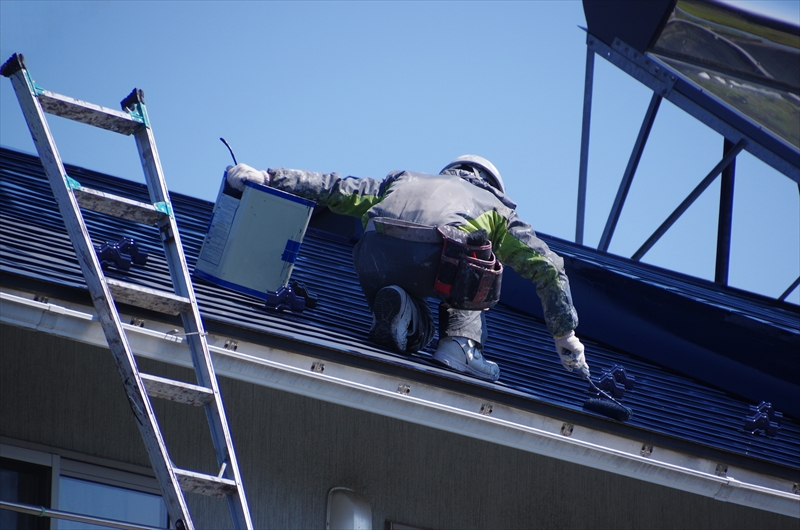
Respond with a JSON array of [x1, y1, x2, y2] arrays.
[[353, 231, 487, 349]]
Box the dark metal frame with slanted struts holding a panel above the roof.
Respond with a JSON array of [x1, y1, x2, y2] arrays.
[[575, 0, 800, 300]]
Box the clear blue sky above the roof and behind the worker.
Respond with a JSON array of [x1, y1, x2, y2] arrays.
[[0, 0, 800, 303]]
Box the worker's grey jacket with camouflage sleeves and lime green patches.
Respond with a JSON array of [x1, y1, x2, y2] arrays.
[[268, 168, 578, 335]]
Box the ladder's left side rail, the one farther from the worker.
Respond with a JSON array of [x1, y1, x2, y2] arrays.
[[4, 68, 193, 530]]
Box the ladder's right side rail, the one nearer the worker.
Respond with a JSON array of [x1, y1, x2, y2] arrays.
[[133, 125, 253, 528]]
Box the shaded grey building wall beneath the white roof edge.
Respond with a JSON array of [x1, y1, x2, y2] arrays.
[[0, 325, 797, 530]]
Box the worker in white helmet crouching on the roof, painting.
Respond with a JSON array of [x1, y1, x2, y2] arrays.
[[227, 155, 589, 381]]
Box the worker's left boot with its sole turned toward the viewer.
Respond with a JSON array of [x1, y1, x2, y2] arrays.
[[369, 285, 416, 353]]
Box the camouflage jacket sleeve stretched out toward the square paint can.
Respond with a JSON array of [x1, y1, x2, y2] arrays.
[[268, 168, 385, 217]]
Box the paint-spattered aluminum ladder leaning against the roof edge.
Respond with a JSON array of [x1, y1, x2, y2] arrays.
[[0, 54, 253, 530]]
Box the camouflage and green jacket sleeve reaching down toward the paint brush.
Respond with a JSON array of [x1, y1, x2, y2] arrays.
[[493, 209, 578, 336]]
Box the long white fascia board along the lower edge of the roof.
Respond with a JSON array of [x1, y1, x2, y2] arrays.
[[0, 289, 800, 518]]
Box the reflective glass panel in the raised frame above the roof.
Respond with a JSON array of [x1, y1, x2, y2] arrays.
[[651, 0, 800, 148]]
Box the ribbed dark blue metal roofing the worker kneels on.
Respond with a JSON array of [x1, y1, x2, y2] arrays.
[[0, 149, 800, 470]]
